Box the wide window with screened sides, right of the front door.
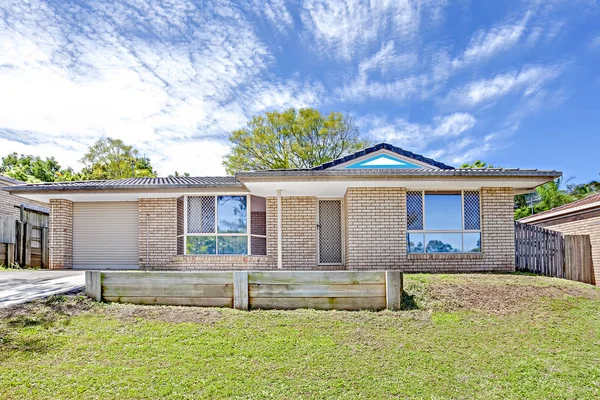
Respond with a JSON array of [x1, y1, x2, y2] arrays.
[[406, 191, 481, 253]]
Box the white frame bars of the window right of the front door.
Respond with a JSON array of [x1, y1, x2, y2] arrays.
[[406, 190, 483, 254]]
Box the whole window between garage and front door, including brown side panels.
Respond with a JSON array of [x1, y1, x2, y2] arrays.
[[177, 195, 266, 255]]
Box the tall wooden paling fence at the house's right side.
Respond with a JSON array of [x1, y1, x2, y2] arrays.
[[515, 222, 595, 284]]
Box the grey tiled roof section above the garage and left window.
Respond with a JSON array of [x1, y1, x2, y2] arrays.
[[2, 176, 243, 192]]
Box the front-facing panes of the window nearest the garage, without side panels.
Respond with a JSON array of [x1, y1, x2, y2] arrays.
[[185, 196, 248, 254]]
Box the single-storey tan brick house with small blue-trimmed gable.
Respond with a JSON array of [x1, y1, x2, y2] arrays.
[[2, 143, 561, 272]]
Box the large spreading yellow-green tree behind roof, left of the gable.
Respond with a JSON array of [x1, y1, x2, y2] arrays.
[[223, 108, 369, 174]]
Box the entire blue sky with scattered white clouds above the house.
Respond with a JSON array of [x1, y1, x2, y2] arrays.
[[0, 0, 600, 182]]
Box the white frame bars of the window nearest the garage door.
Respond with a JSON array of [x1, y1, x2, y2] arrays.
[[177, 193, 260, 256]]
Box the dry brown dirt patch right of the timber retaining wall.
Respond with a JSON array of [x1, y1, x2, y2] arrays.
[[427, 275, 600, 315]]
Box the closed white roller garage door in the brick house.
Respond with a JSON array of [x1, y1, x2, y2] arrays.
[[73, 201, 139, 269]]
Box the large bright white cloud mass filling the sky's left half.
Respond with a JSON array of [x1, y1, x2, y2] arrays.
[[0, 0, 323, 174]]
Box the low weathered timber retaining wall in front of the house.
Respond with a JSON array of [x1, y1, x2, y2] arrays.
[[85, 271, 402, 310]]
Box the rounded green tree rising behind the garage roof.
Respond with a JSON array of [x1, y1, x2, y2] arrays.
[[81, 138, 156, 179]]
